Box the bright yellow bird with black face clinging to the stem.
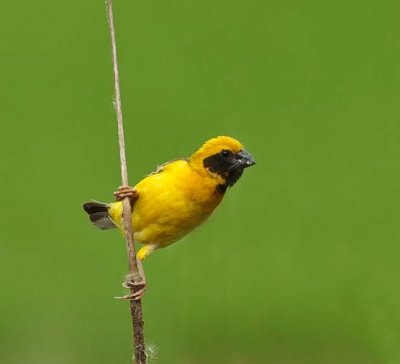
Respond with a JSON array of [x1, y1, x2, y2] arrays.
[[83, 136, 255, 260]]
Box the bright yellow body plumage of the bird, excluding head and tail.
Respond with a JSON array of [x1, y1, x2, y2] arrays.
[[109, 161, 223, 248]]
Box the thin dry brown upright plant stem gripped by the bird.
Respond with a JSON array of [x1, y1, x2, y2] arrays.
[[106, 0, 146, 364]]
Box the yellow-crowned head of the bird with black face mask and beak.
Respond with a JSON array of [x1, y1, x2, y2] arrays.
[[189, 136, 255, 192]]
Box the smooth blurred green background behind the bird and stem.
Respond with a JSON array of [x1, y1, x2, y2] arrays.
[[0, 0, 400, 364]]
